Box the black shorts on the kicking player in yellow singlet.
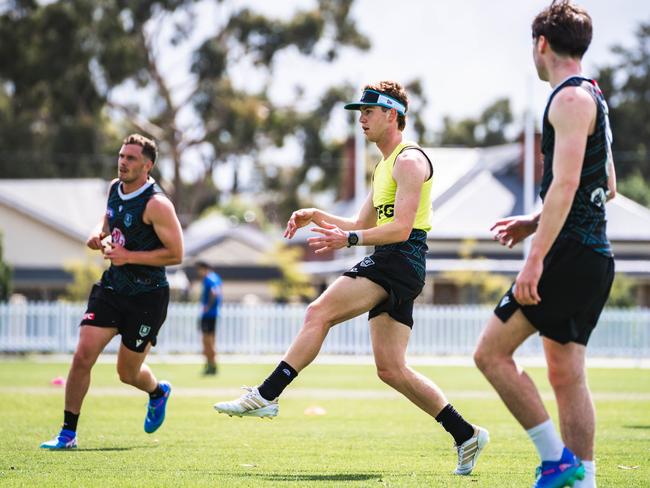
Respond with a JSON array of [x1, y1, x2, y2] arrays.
[[343, 250, 424, 328]]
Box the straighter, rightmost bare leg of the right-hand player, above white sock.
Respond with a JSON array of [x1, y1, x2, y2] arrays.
[[544, 338, 596, 461]]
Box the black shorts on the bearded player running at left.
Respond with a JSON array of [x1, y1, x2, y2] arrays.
[[80, 284, 169, 352]]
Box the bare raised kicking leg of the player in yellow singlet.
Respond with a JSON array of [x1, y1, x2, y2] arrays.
[[283, 276, 388, 372]]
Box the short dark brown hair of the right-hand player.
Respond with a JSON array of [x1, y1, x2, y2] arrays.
[[532, 0, 592, 58]]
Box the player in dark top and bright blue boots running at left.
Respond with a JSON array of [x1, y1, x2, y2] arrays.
[[41, 134, 183, 449]]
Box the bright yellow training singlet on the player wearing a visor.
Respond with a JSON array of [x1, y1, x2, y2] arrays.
[[372, 141, 433, 232]]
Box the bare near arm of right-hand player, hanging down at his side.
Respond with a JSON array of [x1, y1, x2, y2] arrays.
[[515, 87, 596, 305]]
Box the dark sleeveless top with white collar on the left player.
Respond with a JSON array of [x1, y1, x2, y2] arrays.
[[101, 177, 169, 295]]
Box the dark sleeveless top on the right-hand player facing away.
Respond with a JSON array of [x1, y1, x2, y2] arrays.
[[540, 76, 612, 256]]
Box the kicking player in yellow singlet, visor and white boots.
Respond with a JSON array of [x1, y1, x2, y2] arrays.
[[214, 81, 489, 475]]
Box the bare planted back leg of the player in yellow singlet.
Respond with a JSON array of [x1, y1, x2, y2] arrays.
[[370, 313, 449, 418]]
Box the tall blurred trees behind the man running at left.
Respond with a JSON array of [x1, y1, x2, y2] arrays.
[[0, 0, 369, 221]]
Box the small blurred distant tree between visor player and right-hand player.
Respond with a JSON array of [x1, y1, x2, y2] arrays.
[[437, 98, 513, 147]]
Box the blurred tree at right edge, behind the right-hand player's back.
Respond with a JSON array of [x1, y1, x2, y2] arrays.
[[596, 20, 650, 181]]
